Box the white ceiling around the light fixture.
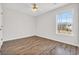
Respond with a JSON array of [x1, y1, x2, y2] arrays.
[[3, 3, 66, 16]]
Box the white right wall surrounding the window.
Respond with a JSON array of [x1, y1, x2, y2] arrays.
[[37, 4, 78, 45]]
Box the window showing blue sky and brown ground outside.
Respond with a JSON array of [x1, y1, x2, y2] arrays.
[[56, 11, 73, 35]]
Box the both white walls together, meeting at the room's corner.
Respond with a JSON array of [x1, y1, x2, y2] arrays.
[[3, 4, 79, 45]]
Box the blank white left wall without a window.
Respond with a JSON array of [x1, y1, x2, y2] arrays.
[[3, 8, 35, 41]]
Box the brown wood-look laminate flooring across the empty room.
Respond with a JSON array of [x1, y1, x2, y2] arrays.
[[1, 36, 79, 55]]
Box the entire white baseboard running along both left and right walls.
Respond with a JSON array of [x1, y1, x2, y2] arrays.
[[4, 35, 79, 47]]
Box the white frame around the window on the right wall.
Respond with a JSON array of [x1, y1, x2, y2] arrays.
[[56, 8, 74, 36]]
